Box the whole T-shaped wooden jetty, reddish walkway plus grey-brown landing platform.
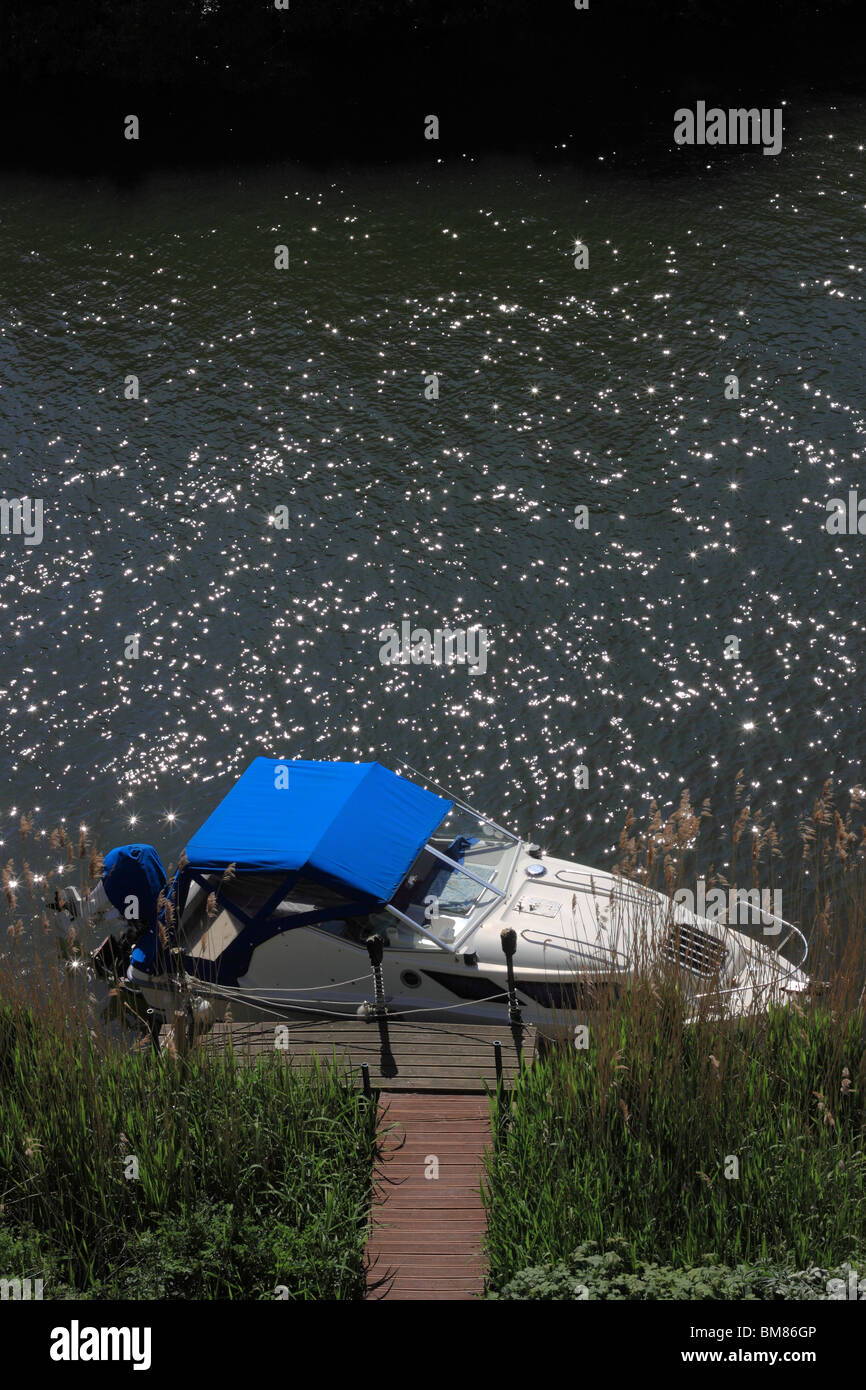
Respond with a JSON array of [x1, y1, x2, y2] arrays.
[[163, 1017, 537, 1301]]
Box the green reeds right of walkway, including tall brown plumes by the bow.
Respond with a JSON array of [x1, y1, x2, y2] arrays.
[[485, 784, 866, 1298]]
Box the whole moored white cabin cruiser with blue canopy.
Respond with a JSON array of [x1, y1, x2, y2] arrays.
[[64, 758, 808, 1031]]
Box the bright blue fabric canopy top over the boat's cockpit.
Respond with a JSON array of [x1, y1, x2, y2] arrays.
[[186, 758, 453, 902]]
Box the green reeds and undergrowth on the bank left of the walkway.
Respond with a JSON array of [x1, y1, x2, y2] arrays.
[[0, 1004, 375, 1300]]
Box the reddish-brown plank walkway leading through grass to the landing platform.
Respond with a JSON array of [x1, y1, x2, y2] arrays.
[[367, 1093, 491, 1301]]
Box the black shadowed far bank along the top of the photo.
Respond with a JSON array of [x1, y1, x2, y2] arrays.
[[0, 0, 860, 177]]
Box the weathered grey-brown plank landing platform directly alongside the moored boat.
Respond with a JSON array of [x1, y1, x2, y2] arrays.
[[161, 1019, 535, 1095]]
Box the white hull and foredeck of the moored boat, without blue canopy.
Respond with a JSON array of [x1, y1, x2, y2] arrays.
[[131, 844, 808, 1033]]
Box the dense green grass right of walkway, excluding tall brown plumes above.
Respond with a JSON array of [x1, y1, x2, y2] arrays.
[[485, 986, 866, 1289]]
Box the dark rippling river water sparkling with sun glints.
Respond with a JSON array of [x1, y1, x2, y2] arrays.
[[0, 106, 866, 895]]
